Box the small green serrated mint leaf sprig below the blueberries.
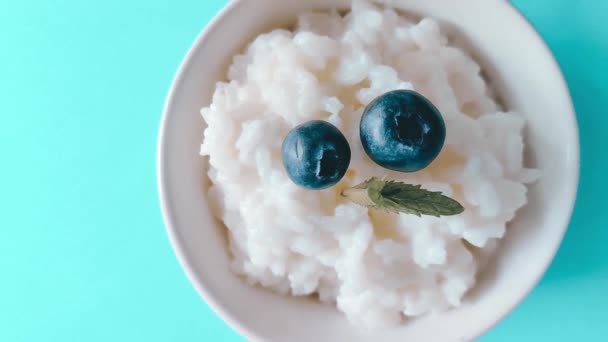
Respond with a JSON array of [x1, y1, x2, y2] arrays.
[[342, 177, 464, 217]]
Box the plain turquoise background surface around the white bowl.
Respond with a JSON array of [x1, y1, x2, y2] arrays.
[[0, 0, 608, 342]]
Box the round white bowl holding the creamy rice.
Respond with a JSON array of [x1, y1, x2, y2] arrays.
[[158, 0, 579, 342]]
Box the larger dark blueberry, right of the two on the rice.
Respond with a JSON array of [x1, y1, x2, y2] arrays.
[[359, 90, 445, 172]]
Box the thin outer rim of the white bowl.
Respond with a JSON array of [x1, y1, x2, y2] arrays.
[[156, 0, 580, 341]]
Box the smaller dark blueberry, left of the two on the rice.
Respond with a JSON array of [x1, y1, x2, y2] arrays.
[[281, 120, 350, 190]]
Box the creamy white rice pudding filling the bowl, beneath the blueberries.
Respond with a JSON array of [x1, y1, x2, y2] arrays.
[[201, 1, 538, 328]]
